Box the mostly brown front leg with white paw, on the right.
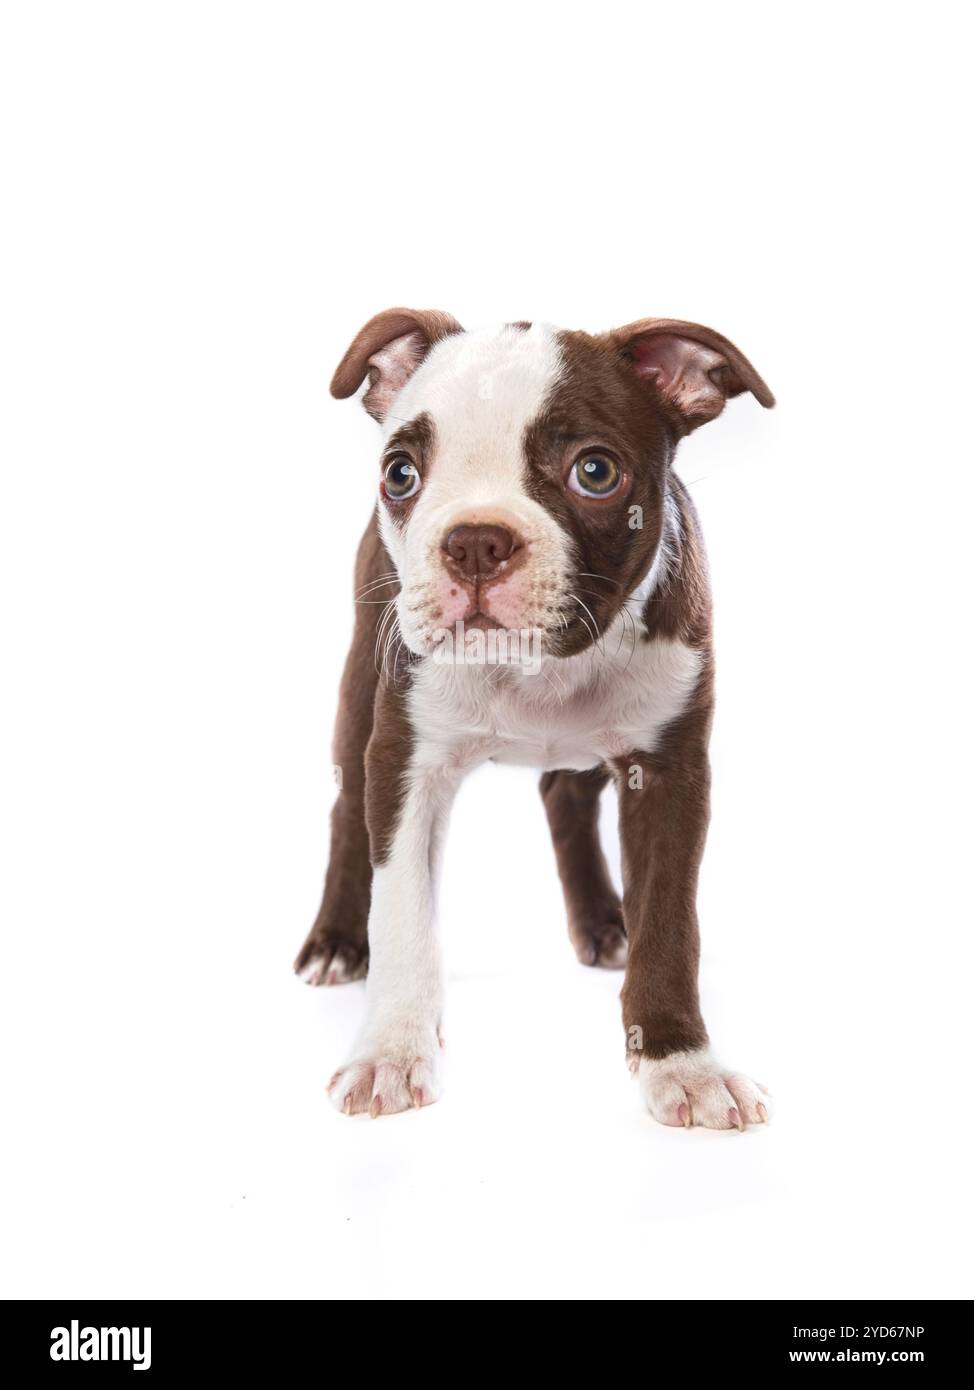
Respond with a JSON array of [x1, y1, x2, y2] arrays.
[[616, 713, 768, 1129]]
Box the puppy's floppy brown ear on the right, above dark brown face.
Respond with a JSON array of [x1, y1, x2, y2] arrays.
[[607, 318, 774, 431]]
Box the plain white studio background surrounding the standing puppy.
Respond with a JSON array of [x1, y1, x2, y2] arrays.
[[0, 0, 974, 1301]]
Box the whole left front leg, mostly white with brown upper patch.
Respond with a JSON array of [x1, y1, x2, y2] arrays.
[[328, 681, 459, 1116]]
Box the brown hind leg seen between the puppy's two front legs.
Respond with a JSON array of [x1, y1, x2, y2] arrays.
[[540, 767, 627, 970]]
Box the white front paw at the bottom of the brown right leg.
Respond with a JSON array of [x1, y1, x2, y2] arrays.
[[636, 1048, 770, 1130]]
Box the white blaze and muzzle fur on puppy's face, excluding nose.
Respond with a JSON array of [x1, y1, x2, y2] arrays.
[[379, 325, 571, 653]]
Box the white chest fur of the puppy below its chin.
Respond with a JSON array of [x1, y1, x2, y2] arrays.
[[410, 642, 703, 771]]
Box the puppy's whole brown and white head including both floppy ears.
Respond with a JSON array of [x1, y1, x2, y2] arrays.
[[332, 309, 774, 656]]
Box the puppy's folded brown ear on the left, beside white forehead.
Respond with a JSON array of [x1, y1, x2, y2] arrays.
[[332, 309, 463, 421]]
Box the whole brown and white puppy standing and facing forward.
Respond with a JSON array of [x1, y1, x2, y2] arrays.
[[296, 309, 774, 1129]]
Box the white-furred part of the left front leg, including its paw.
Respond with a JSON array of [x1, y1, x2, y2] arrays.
[[328, 765, 460, 1116]]
